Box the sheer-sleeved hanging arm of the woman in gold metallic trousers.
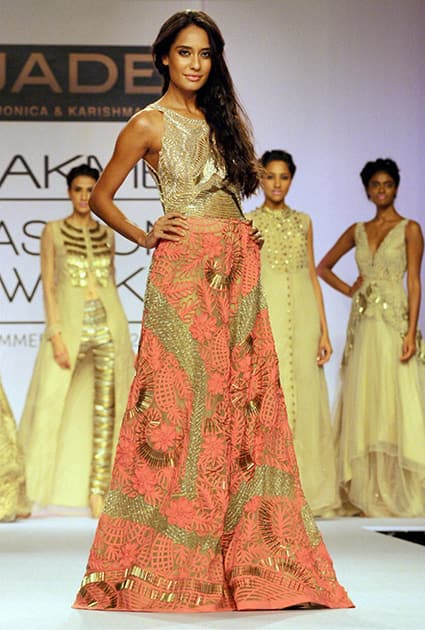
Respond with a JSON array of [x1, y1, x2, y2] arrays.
[[40, 223, 71, 369]]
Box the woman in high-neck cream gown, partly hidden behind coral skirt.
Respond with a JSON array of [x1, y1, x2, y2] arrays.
[[248, 150, 339, 517]]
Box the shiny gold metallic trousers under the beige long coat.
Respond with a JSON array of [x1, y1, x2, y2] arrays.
[[77, 299, 115, 495]]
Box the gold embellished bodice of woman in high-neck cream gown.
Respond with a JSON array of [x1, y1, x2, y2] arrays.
[[250, 206, 310, 272]]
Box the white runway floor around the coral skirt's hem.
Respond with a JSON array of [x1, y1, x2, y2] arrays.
[[0, 516, 425, 630]]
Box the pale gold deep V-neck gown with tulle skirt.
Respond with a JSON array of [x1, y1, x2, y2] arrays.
[[335, 219, 425, 517]]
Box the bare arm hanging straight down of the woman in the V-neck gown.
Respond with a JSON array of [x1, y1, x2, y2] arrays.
[[400, 221, 424, 362]]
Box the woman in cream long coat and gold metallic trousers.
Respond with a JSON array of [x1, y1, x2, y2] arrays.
[[19, 164, 133, 516]]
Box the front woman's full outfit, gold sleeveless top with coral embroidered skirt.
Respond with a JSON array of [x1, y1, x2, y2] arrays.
[[75, 107, 352, 612]]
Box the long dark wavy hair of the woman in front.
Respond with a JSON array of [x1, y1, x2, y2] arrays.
[[152, 10, 258, 197]]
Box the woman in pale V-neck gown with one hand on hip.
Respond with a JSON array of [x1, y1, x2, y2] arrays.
[[319, 159, 425, 517]]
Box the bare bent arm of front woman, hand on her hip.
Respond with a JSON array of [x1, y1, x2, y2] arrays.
[[89, 112, 186, 248]]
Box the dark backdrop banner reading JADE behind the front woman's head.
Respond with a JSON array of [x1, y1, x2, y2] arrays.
[[0, 44, 162, 121]]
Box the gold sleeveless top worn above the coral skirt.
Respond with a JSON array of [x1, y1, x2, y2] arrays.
[[147, 105, 244, 219]]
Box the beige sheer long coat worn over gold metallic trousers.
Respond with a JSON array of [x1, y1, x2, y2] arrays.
[[19, 220, 133, 506]]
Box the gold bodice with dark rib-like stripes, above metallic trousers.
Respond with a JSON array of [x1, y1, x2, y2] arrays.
[[60, 219, 111, 288]]
